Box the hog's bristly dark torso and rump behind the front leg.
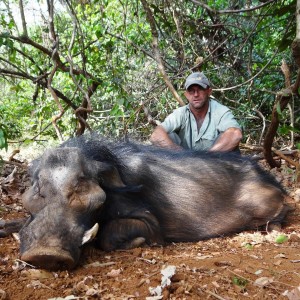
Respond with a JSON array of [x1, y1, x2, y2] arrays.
[[117, 151, 283, 241]]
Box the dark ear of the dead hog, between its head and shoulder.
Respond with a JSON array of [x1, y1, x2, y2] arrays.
[[94, 161, 126, 189]]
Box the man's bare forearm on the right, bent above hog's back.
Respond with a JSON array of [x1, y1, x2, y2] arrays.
[[209, 127, 243, 151]]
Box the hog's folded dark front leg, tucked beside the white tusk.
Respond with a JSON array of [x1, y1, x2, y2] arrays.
[[97, 219, 163, 251]]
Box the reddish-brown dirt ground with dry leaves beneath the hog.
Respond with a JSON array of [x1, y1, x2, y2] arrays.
[[0, 154, 300, 300]]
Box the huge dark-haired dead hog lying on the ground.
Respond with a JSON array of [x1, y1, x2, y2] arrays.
[[0, 137, 288, 269]]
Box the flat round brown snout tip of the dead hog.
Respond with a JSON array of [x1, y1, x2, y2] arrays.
[[21, 248, 76, 271]]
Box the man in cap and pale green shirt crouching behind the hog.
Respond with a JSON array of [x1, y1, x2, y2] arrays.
[[150, 72, 242, 151]]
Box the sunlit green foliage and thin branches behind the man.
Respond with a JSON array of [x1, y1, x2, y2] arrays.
[[0, 0, 299, 146]]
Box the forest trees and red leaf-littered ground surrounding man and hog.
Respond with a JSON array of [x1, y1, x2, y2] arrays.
[[0, 0, 300, 300]]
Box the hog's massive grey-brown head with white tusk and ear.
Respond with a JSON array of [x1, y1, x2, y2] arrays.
[[20, 148, 124, 269]]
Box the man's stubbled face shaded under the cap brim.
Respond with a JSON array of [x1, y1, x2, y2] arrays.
[[184, 84, 211, 110]]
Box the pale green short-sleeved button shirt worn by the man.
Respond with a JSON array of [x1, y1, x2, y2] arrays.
[[161, 99, 241, 150]]
